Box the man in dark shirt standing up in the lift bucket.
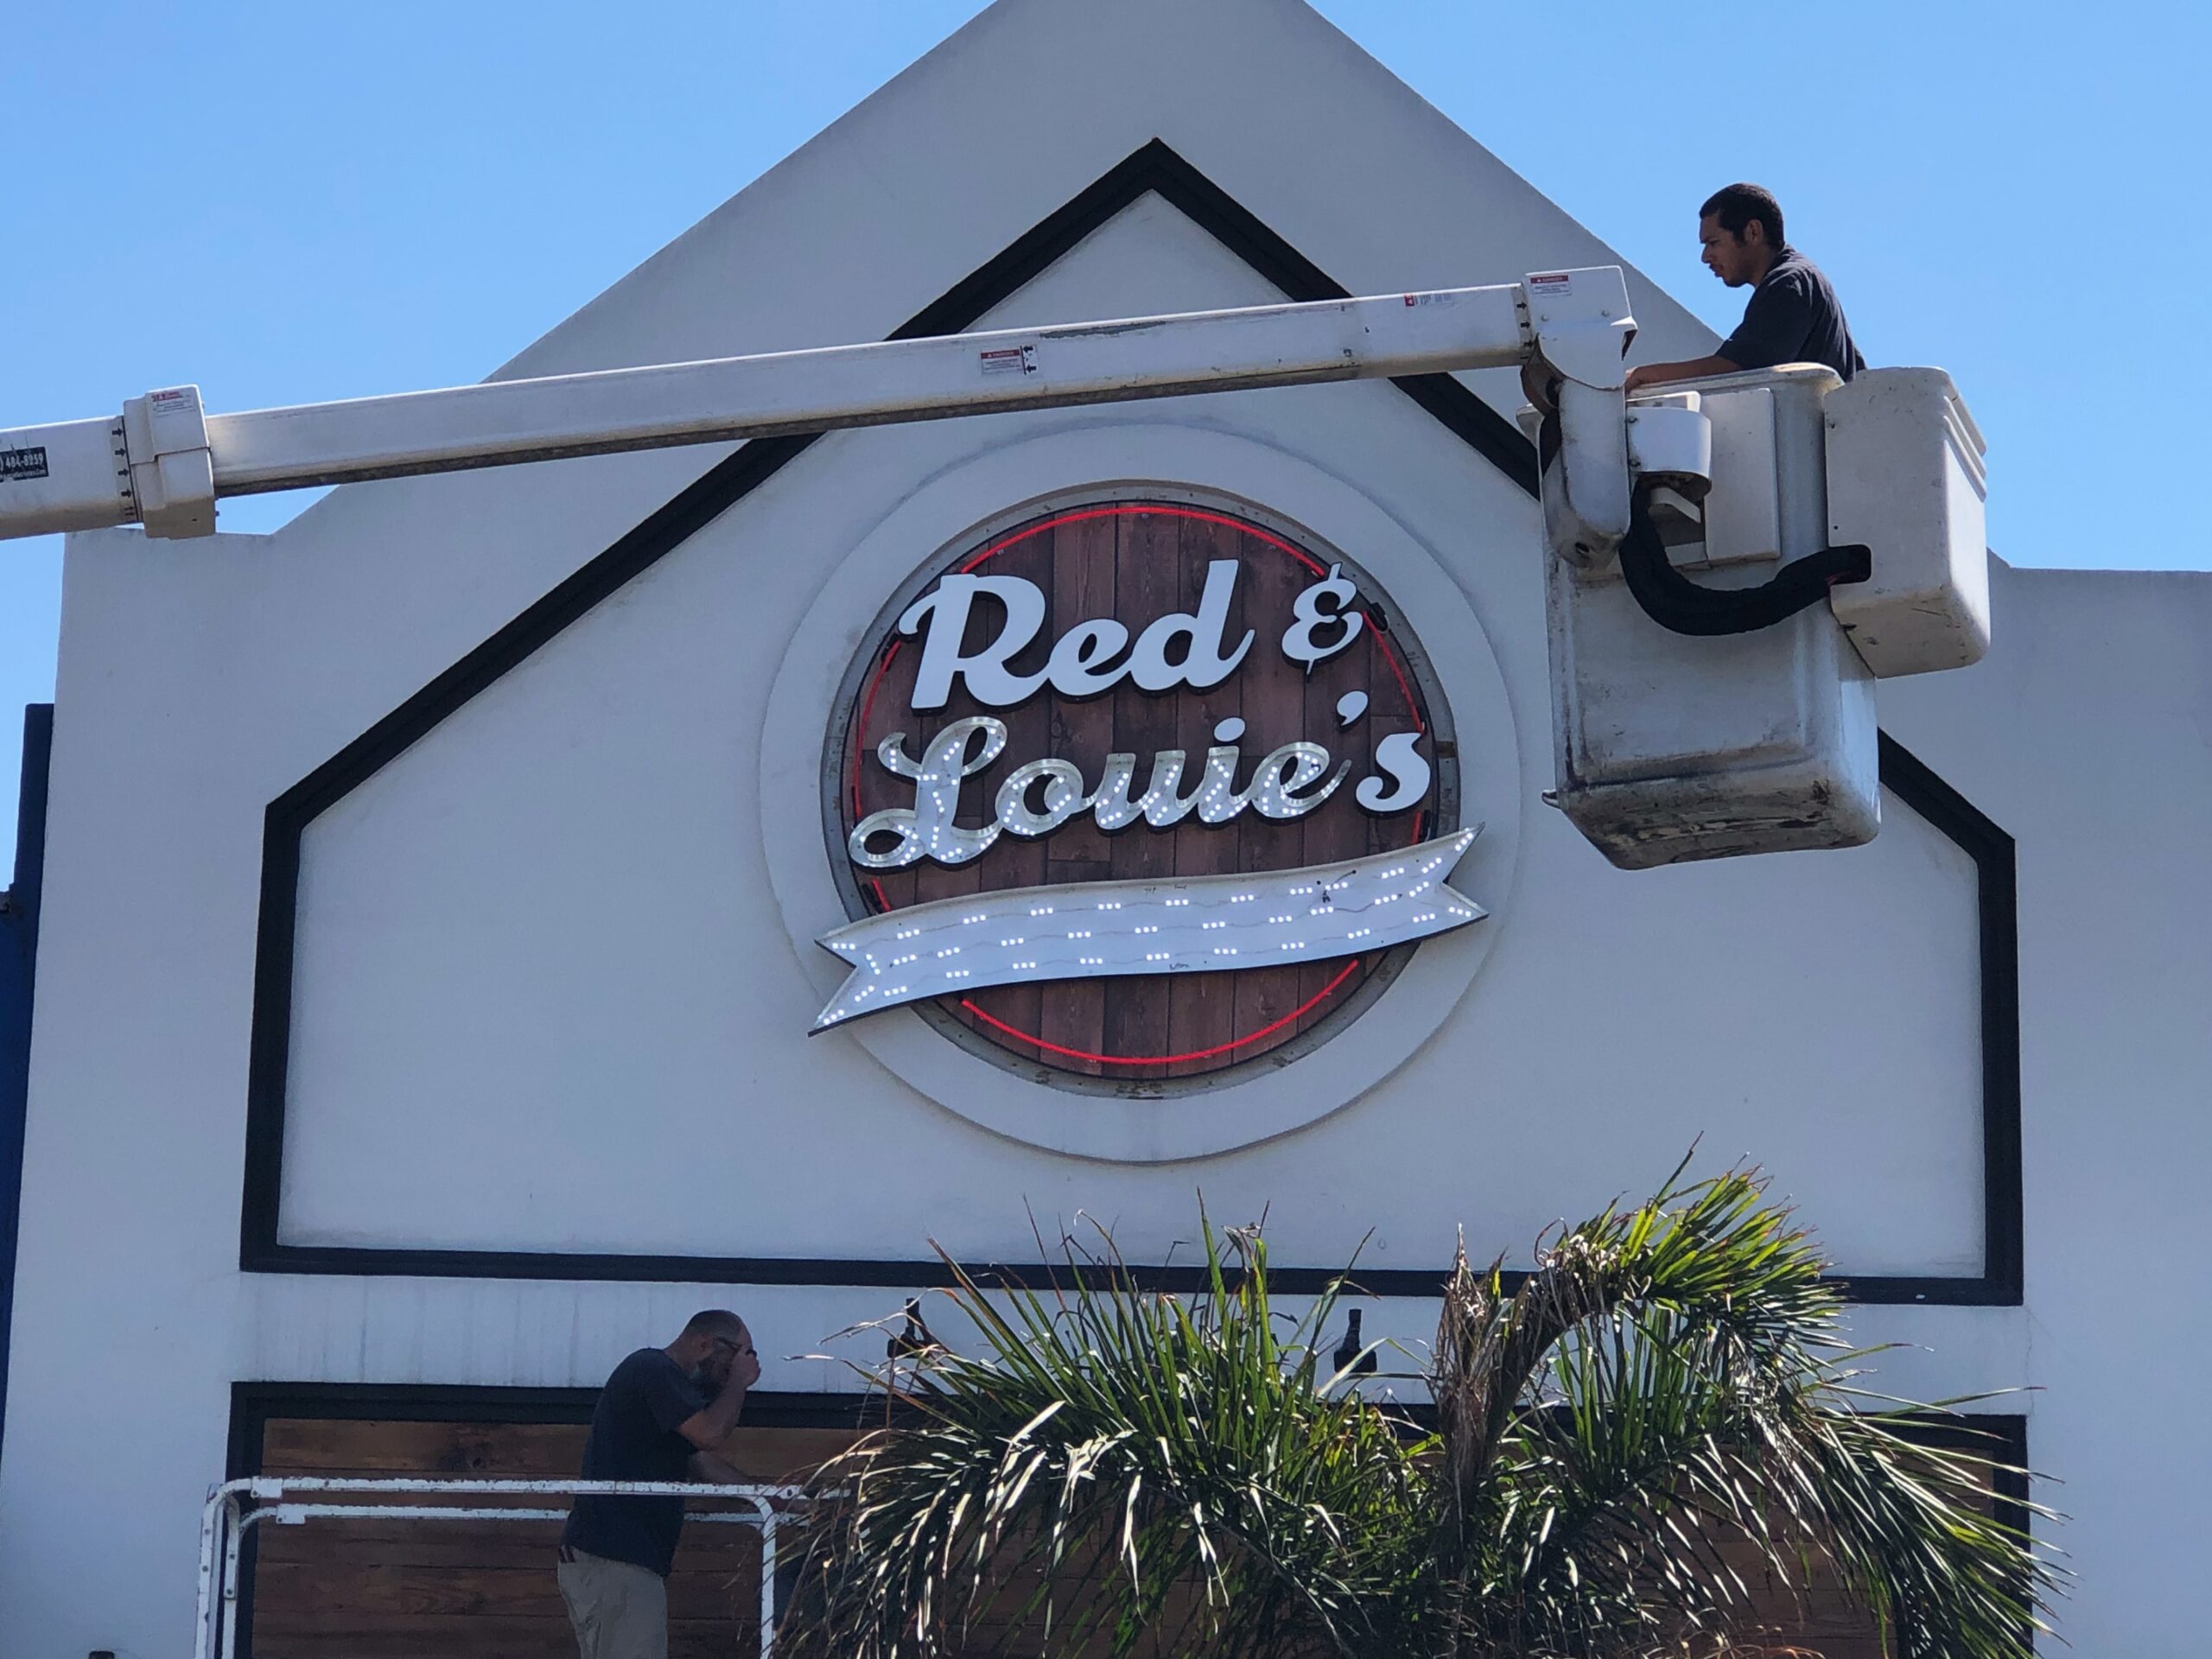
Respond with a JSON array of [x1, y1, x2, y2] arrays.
[[1628, 183, 1867, 391]]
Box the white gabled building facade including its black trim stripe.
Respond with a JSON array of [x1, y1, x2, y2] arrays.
[[0, 0, 2212, 1659]]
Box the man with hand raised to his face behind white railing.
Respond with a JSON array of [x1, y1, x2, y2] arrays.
[[560, 1307, 761, 1659]]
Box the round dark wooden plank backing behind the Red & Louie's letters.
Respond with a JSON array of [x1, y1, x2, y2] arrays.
[[832, 502, 1451, 1082]]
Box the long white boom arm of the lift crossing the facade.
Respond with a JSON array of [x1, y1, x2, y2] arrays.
[[0, 265, 1635, 556]]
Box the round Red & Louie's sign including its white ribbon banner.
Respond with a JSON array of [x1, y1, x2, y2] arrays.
[[818, 498, 1482, 1089]]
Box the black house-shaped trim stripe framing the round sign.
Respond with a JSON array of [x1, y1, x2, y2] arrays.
[[238, 139, 2019, 1305]]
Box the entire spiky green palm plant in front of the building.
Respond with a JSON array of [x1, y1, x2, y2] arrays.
[[787, 1168, 2057, 1659]]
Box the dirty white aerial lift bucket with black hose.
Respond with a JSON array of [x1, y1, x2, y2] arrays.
[[1522, 365, 1988, 869]]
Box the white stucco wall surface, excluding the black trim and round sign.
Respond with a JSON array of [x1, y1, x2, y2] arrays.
[[0, 0, 2212, 1659]]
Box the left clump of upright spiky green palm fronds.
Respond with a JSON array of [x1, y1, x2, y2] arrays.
[[814, 1225, 1418, 1659]]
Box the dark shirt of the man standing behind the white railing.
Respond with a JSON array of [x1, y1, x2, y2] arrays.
[[560, 1347, 706, 1577]]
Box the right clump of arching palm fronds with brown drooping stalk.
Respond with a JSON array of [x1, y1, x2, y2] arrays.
[[1438, 1170, 2057, 1659]]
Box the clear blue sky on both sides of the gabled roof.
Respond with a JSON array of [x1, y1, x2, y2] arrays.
[[0, 0, 2212, 882]]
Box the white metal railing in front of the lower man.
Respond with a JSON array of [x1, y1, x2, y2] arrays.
[[193, 1476, 821, 1659]]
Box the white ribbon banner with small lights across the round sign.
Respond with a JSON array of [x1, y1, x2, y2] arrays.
[[814, 825, 1489, 1031]]
